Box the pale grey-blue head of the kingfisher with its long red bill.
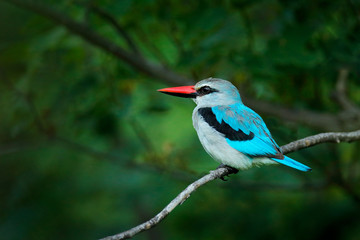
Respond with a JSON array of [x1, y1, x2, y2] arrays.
[[158, 78, 241, 107]]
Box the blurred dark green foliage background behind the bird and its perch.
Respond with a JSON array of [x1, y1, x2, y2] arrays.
[[0, 0, 360, 240]]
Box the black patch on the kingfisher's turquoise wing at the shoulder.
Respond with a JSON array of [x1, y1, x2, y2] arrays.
[[198, 107, 255, 141]]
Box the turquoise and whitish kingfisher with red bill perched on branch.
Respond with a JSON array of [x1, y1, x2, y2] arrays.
[[158, 78, 311, 172]]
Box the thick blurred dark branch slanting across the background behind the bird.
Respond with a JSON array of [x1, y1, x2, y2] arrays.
[[1, 0, 360, 131]]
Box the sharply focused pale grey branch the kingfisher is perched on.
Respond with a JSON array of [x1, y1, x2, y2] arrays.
[[101, 130, 360, 240]]
